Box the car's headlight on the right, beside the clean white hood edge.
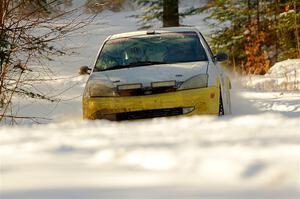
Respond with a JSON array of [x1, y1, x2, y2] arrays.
[[178, 74, 208, 90]]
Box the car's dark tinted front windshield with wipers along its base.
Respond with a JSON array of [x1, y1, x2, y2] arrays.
[[94, 32, 207, 71]]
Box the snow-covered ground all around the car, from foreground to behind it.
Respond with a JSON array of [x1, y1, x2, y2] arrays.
[[0, 7, 300, 199]]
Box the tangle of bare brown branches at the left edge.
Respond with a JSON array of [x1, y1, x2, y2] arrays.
[[0, 0, 95, 123]]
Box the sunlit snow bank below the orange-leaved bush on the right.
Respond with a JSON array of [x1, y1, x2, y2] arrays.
[[242, 59, 300, 91]]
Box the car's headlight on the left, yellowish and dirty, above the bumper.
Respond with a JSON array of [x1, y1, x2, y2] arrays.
[[88, 82, 118, 97]]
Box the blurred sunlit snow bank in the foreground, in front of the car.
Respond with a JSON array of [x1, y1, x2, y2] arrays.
[[0, 114, 300, 199]]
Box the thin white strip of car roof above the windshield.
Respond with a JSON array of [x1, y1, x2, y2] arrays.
[[109, 27, 198, 39]]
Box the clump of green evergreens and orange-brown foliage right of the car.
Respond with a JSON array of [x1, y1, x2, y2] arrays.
[[194, 0, 300, 74]]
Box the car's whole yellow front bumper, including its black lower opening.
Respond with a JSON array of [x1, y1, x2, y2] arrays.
[[83, 86, 220, 121]]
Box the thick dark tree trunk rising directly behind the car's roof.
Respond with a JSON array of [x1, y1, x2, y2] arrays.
[[163, 0, 179, 27]]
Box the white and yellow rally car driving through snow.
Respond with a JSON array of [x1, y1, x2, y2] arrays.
[[80, 27, 231, 121]]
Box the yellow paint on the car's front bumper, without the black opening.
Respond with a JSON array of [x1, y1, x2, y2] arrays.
[[83, 86, 220, 119]]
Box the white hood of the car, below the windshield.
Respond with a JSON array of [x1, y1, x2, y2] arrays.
[[90, 61, 208, 87]]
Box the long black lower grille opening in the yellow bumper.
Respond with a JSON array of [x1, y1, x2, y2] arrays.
[[116, 108, 183, 121]]
